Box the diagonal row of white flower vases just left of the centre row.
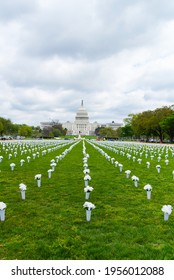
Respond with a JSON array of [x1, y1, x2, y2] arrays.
[[0, 139, 78, 221]]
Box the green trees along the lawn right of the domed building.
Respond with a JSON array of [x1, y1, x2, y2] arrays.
[[96, 105, 174, 143]]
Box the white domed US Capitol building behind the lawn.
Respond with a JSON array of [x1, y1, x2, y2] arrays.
[[40, 100, 122, 136]]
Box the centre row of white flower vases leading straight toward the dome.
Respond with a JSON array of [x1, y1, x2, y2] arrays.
[[83, 141, 95, 222]]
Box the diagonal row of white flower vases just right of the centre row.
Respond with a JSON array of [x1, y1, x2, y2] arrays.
[[88, 141, 174, 221]]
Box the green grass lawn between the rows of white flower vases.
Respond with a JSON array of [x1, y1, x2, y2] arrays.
[[0, 141, 174, 260]]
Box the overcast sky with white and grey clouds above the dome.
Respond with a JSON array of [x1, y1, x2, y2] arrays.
[[0, 0, 174, 125]]
